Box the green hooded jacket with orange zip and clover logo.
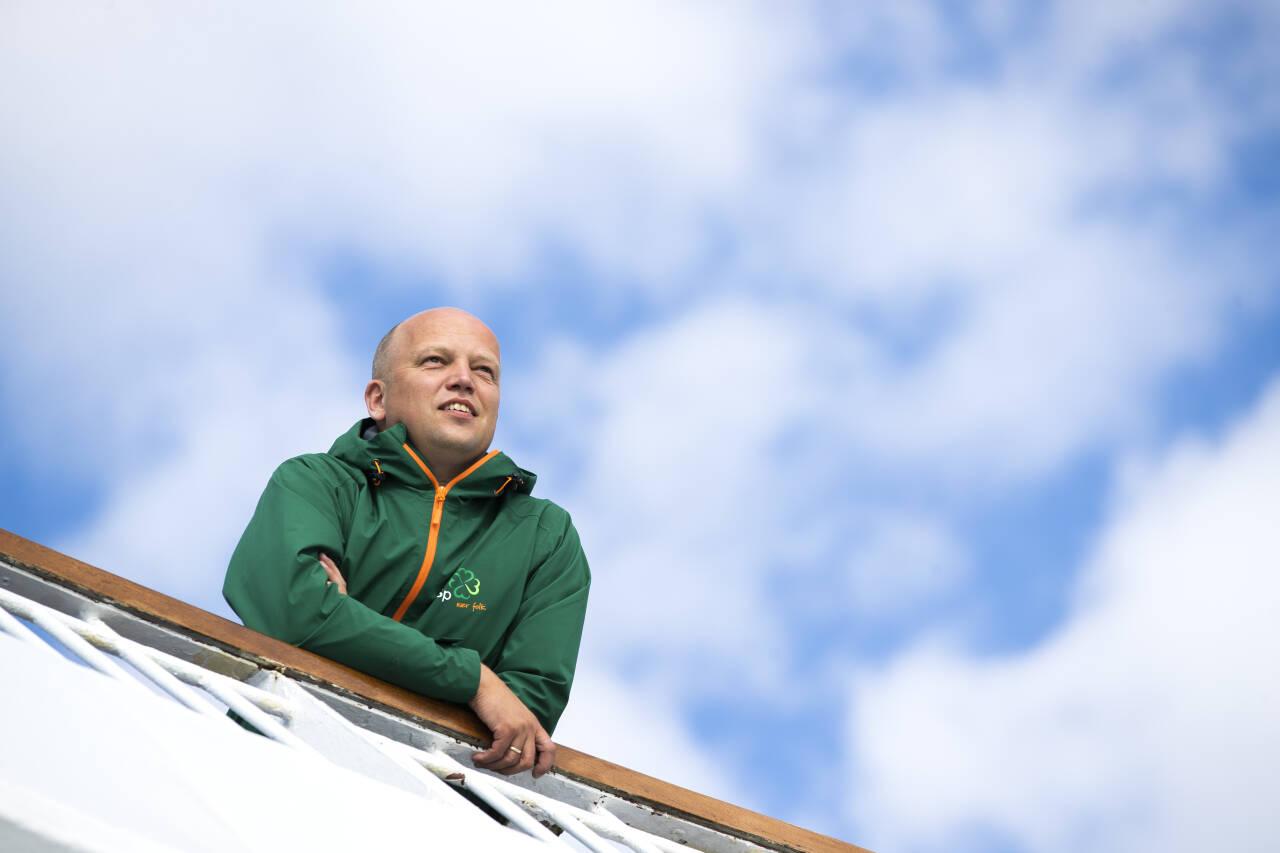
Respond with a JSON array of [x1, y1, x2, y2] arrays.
[[223, 420, 591, 731]]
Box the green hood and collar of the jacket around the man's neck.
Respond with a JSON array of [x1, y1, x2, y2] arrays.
[[329, 418, 538, 497]]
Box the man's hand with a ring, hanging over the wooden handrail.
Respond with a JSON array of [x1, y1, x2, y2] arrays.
[[468, 663, 556, 779]]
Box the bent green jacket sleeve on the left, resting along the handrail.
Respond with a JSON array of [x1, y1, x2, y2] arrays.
[[223, 456, 480, 702]]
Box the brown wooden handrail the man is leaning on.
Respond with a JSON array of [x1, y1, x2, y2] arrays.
[[0, 528, 868, 853]]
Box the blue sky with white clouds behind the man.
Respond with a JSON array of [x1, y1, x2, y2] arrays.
[[0, 0, 1280, 852]]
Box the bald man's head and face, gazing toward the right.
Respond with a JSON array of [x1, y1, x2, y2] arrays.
[[365, 309, 502, 483]]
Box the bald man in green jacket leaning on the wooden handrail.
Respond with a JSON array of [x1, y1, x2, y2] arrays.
[[223, 309, 590, 776]]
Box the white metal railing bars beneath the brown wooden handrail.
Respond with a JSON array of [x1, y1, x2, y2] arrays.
[[0, 566, 764, 853]]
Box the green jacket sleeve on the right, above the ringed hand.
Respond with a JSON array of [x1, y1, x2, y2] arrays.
[[490, 505, 591, 733]]
